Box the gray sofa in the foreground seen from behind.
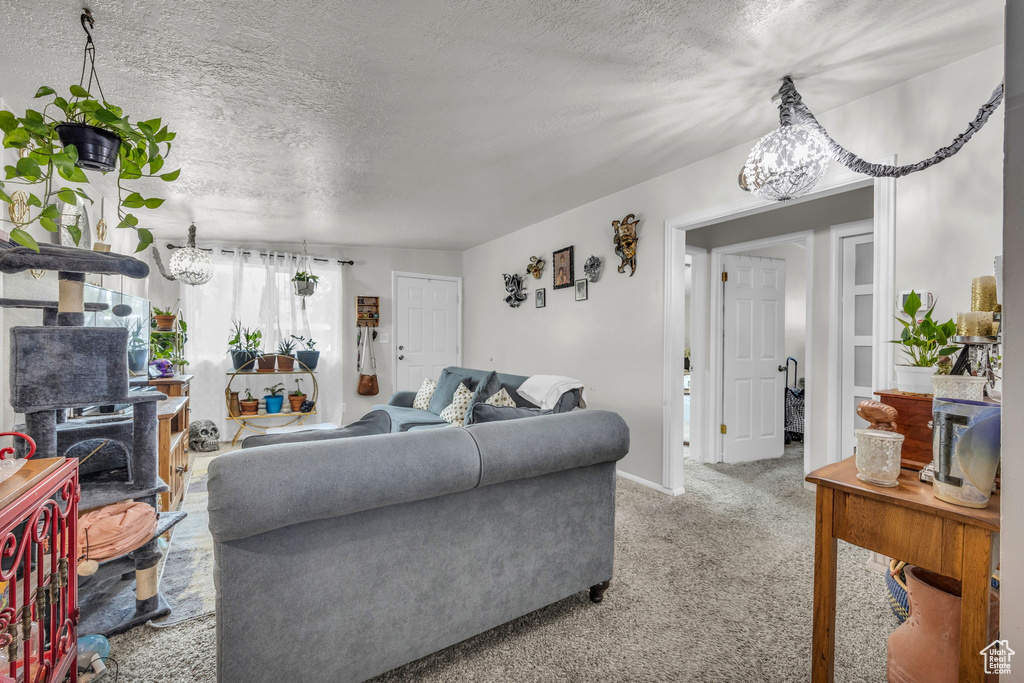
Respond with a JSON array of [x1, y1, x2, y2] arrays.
[[209, 411, 629, 683]]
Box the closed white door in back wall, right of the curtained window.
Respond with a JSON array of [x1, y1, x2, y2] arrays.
[[394, 275, 461, 391]]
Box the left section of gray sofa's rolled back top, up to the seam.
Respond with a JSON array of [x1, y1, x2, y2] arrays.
[[207, 429, 480, 543]]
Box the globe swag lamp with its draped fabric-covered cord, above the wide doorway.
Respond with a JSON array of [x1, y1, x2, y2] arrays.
[[739, 76, 1002, 202]]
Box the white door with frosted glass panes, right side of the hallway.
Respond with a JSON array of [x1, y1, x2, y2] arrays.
[[839, 232, 874, 458]]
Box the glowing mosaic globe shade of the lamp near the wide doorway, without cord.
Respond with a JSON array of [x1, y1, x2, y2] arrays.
[[743, 124, 828, 202]]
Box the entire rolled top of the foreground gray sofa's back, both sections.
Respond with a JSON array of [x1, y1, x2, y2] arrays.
[[208, 411, 630, 543]]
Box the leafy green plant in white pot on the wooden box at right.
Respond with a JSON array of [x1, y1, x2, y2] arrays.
[[891, 291, 959, 393]]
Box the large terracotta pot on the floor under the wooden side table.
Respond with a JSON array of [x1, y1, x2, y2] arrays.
[[887, 566, 999, 683]]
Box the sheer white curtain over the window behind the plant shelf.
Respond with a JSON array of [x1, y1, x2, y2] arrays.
[[181, 247, 343, 440]]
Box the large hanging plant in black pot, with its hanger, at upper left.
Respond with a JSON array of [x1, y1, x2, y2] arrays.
[[0, 10, 180, 252]]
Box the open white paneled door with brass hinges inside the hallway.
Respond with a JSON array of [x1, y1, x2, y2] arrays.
[[722, 254, 785, 463]]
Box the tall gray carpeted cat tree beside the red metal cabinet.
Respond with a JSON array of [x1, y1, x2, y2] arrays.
[[0, 242, 185, 636]]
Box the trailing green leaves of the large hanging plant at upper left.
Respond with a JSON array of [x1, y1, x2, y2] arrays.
[[0, 85, 181, 252]]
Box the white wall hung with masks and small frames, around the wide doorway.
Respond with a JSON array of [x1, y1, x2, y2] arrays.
[[463, 47, 1002, 483]]
